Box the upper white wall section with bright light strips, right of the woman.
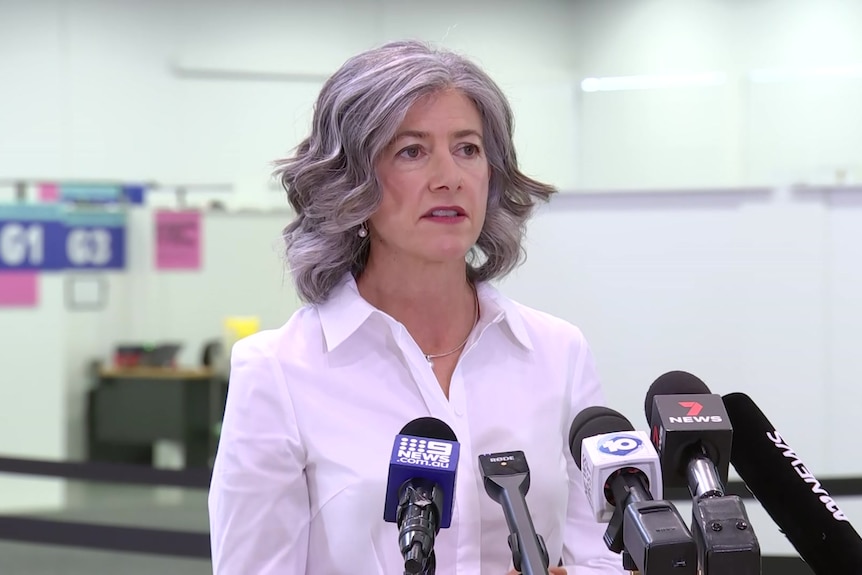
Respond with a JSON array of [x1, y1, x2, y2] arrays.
[[573, 0, 862, 189]]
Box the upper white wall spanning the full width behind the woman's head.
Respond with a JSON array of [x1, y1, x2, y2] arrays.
[[5, 0, 862, 196]]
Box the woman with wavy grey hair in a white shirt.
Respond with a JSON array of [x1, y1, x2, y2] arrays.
[[210, 42, 621, 575]]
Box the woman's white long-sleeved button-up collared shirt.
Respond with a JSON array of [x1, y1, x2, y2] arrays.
[[209, 275, 623, 575]]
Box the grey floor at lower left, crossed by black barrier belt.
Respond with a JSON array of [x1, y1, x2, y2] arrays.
[[0, 483, 212, 575]]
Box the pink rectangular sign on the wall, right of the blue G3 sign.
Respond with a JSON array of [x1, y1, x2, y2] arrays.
[[155, 210, 202, 270]]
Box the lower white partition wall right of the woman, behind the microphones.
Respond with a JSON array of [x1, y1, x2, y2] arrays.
[[504, 190, 840, 473]]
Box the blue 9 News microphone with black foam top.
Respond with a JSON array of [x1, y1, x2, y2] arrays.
[[383, 417, 460, 574]]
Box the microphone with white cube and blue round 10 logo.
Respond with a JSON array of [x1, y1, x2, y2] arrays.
[[569, 406, 697, 575]]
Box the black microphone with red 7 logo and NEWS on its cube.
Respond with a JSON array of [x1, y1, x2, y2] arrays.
[[644, 371, 761, 575]]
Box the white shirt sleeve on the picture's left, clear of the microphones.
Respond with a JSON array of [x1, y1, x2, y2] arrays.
[[208, 334, 309, 575]]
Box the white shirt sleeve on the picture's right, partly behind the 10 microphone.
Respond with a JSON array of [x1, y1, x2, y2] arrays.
[[563, 336, 628, 575]]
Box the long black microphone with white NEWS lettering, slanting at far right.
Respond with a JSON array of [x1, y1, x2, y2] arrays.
[[724, 393, 862, 575]]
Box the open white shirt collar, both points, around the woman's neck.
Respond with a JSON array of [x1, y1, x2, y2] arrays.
[[317, 273, 533, 351]]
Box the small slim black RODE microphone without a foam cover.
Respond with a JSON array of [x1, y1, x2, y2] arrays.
[[479, 451, 548, 575]]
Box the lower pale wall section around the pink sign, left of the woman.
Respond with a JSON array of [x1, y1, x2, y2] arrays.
[[120, 209, 300, 366]]
